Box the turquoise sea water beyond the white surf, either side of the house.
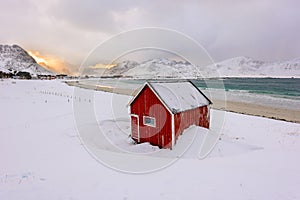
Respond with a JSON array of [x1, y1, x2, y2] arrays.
[[92, 78, 300, 101]]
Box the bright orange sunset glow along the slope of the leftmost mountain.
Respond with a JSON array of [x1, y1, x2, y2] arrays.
[[28, 51, 71, 74]]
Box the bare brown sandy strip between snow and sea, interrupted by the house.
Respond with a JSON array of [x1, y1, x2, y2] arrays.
[[66, 81, 300, 123]]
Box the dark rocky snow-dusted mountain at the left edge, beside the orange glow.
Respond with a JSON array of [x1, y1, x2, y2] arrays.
[[0, 45, 53, 75]]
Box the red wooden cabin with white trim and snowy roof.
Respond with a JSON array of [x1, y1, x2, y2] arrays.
[[129, 81, 212, 148]]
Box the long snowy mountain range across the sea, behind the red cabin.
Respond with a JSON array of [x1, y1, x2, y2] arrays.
[[105, 57, 300, 78]]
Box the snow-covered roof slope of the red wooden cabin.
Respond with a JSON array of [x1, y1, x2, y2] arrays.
[[148, 81, 211, 113]]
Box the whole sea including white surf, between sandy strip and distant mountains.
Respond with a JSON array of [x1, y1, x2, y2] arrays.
[[80, 78, 300, 110]]
